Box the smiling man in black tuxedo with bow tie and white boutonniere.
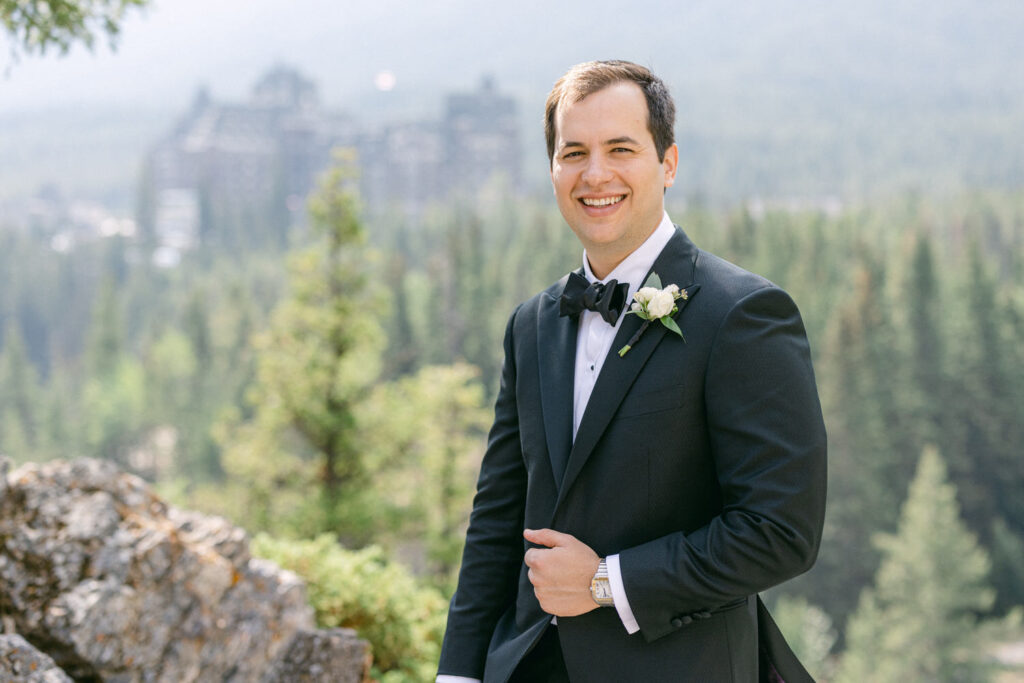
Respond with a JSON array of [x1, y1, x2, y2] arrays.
[[438, 61, 825, 683]]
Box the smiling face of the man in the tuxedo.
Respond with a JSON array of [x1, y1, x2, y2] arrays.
[[551, 81, 679, 278]]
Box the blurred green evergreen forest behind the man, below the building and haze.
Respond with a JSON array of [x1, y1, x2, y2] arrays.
[[0, 163, 1024, 682]]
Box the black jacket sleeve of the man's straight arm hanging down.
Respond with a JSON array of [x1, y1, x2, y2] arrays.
[[438, 309, 526, 678]]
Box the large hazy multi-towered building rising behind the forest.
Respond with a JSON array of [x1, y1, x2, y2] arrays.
[[148, 67, 521, 249]]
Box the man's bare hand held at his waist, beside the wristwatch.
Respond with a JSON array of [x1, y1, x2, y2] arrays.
[[522, 528, 601, 616]]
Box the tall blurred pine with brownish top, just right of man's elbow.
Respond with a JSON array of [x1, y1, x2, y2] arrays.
[[808, 249, 913, 622]]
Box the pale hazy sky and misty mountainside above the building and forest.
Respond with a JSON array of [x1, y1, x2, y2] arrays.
[[0, 0, 1024, 203]]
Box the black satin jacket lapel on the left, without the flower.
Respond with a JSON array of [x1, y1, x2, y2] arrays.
[[537, 274, 579, 486]]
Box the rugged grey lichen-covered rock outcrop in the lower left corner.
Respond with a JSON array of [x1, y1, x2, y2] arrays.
[[0, 459, 369, 683]]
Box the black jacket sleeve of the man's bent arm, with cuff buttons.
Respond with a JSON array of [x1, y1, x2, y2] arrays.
[[620, 287, 825, 641]]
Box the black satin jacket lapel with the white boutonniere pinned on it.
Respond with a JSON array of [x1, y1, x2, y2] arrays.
[[555, 226, 700, 510]]
